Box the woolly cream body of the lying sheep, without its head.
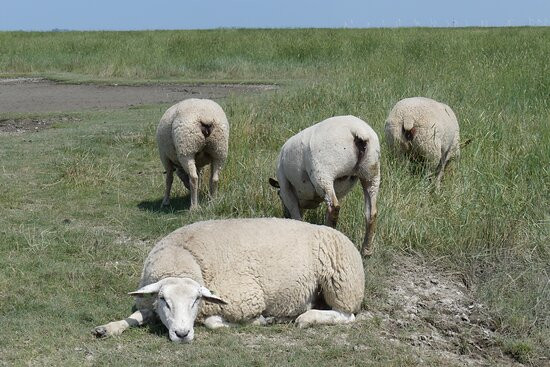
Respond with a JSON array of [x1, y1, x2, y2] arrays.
[[136, 218, 365, 322]]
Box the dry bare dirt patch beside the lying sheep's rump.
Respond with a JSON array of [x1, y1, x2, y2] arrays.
[[358, 257, 519, 366]]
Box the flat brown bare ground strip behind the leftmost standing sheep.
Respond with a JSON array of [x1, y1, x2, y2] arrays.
[[0, 78, 276, 113]]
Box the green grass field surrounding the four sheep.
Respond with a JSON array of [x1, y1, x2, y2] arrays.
[[0, 28, 550, 365]]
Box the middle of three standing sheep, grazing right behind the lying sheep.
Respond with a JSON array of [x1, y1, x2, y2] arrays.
[[269, 116, 380, 256]]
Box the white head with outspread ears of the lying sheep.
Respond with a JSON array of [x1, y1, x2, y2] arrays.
[[129, 278, 226, 343]]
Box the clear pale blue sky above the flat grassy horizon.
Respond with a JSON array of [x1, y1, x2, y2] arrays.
[[0, 0, 550, 31]]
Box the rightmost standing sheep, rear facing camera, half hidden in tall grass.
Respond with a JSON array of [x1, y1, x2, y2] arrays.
[[385, 97, 460, 189]]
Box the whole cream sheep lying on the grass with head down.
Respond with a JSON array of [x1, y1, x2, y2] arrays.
[[93, 218, 365, 342]]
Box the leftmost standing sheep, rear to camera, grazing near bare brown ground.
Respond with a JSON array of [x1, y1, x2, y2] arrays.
[[157, 98, 229, 209]]
